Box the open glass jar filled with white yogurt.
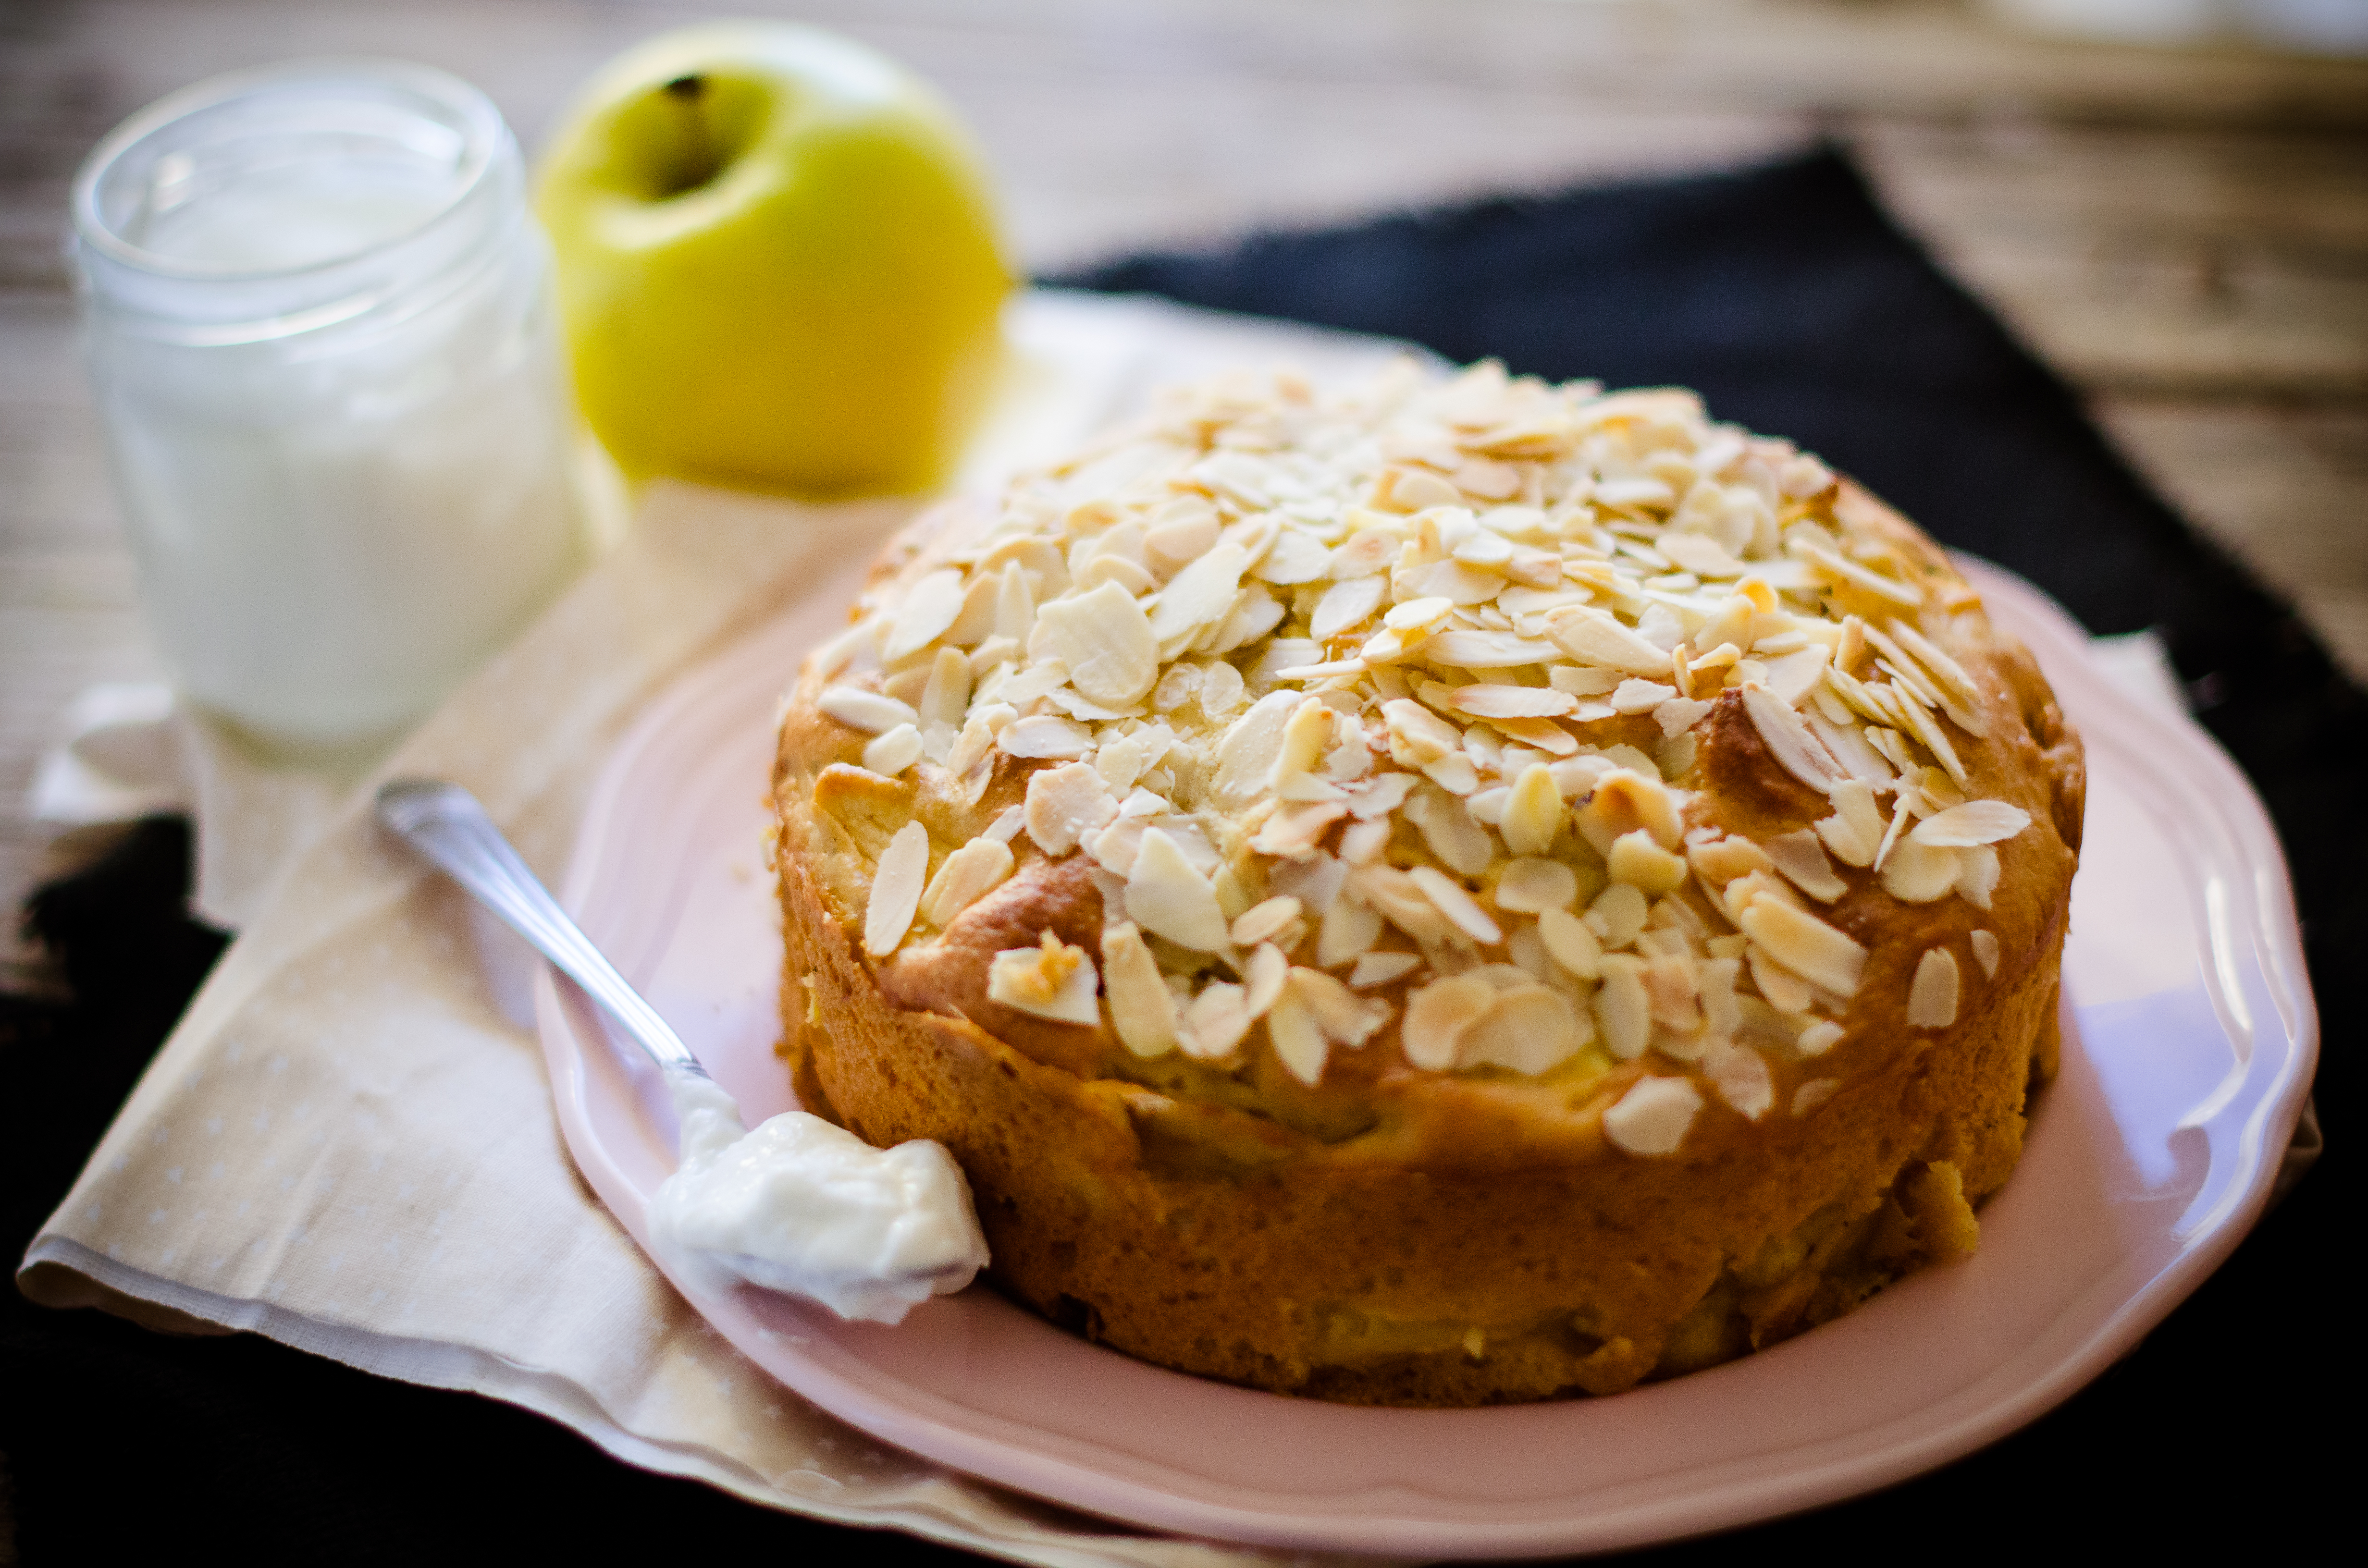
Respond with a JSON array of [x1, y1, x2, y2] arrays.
[[74, 59, 585, 760]]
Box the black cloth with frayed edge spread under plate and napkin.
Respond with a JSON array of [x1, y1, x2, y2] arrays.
[[0, 154, 2330, 1563]]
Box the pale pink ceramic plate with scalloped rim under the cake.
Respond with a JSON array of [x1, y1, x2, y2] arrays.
[[540, 566, 2316, 1556]]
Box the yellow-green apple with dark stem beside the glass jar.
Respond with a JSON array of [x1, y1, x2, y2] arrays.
[[535, 21, 1011, 495]]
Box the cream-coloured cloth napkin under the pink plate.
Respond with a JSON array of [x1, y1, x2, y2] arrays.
[[19, 294, 1420, 1566]]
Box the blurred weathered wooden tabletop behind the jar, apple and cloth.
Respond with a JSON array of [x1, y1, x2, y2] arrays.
[[0, 0, 2368, 983]]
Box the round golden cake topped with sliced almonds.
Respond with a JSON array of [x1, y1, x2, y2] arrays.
[[772, 365, 2084, 1405]]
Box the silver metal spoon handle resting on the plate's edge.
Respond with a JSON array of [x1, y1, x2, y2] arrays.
[[379, 779, 708, 1078]]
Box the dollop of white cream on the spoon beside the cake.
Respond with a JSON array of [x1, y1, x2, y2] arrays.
[[649, 1073, 987, 1324]]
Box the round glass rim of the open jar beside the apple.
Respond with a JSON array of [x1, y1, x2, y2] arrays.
[[71, 54, 509, 282]]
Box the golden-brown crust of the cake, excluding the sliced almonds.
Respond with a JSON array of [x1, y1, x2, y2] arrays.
[[774, 369, 2084, 1405]]
